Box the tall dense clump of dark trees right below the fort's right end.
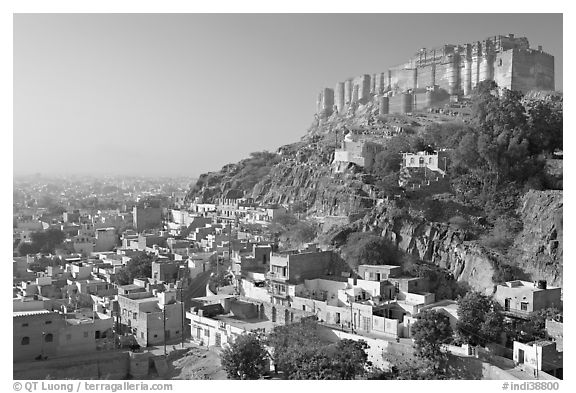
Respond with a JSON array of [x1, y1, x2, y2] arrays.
[[450, 81, 562, 218]]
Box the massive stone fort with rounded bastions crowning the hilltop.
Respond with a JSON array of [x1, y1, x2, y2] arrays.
[[317, 34, 554, 116]]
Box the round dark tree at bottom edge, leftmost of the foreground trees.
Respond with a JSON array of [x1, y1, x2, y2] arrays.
[[220, 333, 269, 379]]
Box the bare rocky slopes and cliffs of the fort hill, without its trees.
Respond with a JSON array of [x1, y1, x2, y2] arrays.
[[190, 95, 563, 292]]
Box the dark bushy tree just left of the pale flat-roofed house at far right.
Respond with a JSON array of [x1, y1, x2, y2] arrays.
[[456, 292, 504, 346]]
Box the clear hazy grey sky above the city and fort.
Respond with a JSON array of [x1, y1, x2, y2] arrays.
[[14, 14, 562, 176]]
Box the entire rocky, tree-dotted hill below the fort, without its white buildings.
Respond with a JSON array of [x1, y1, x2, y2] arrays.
[[191, 82, 563, 288]]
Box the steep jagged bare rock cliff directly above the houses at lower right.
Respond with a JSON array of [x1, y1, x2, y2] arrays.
[[334, 190, 563, 292]]
